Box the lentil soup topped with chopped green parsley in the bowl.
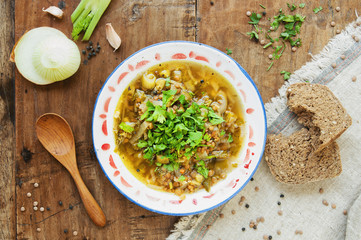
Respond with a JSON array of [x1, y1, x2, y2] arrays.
[[113, 60, 246, 196]]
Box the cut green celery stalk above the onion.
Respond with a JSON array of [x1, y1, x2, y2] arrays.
[[71, 0, 111, 41]]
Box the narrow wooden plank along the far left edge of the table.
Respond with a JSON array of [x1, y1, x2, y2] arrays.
[[0, 1, 16, 239]]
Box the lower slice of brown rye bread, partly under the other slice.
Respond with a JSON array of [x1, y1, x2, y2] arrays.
[[265, 128, 342, 184]]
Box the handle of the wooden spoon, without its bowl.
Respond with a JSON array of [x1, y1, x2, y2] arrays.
[[71, 171, 107, 227]]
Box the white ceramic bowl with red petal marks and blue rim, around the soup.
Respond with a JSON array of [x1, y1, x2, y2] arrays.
[[92, 41, 267, 216]]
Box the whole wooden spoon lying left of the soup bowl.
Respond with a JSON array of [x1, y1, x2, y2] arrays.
[[36, 113, 106, 227]]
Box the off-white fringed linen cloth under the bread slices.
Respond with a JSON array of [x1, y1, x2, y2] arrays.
[[168, 16, 361, 240]]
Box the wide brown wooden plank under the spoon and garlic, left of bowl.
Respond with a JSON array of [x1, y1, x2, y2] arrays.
[[15, 0, 195, 239]]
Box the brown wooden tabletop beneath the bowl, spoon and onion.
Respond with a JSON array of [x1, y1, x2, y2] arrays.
[[0, 0, 361, 239]]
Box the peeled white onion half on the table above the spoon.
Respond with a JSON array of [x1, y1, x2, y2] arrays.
[[13, 27, 81, 85]]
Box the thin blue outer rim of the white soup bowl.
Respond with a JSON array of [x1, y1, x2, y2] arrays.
[[91, 40, 267, 216]]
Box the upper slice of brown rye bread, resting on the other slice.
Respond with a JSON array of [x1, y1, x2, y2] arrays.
[[287, 83, 352, 154]]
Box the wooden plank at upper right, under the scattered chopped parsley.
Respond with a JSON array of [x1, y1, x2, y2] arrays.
[[197, 0, 361, 102]]
